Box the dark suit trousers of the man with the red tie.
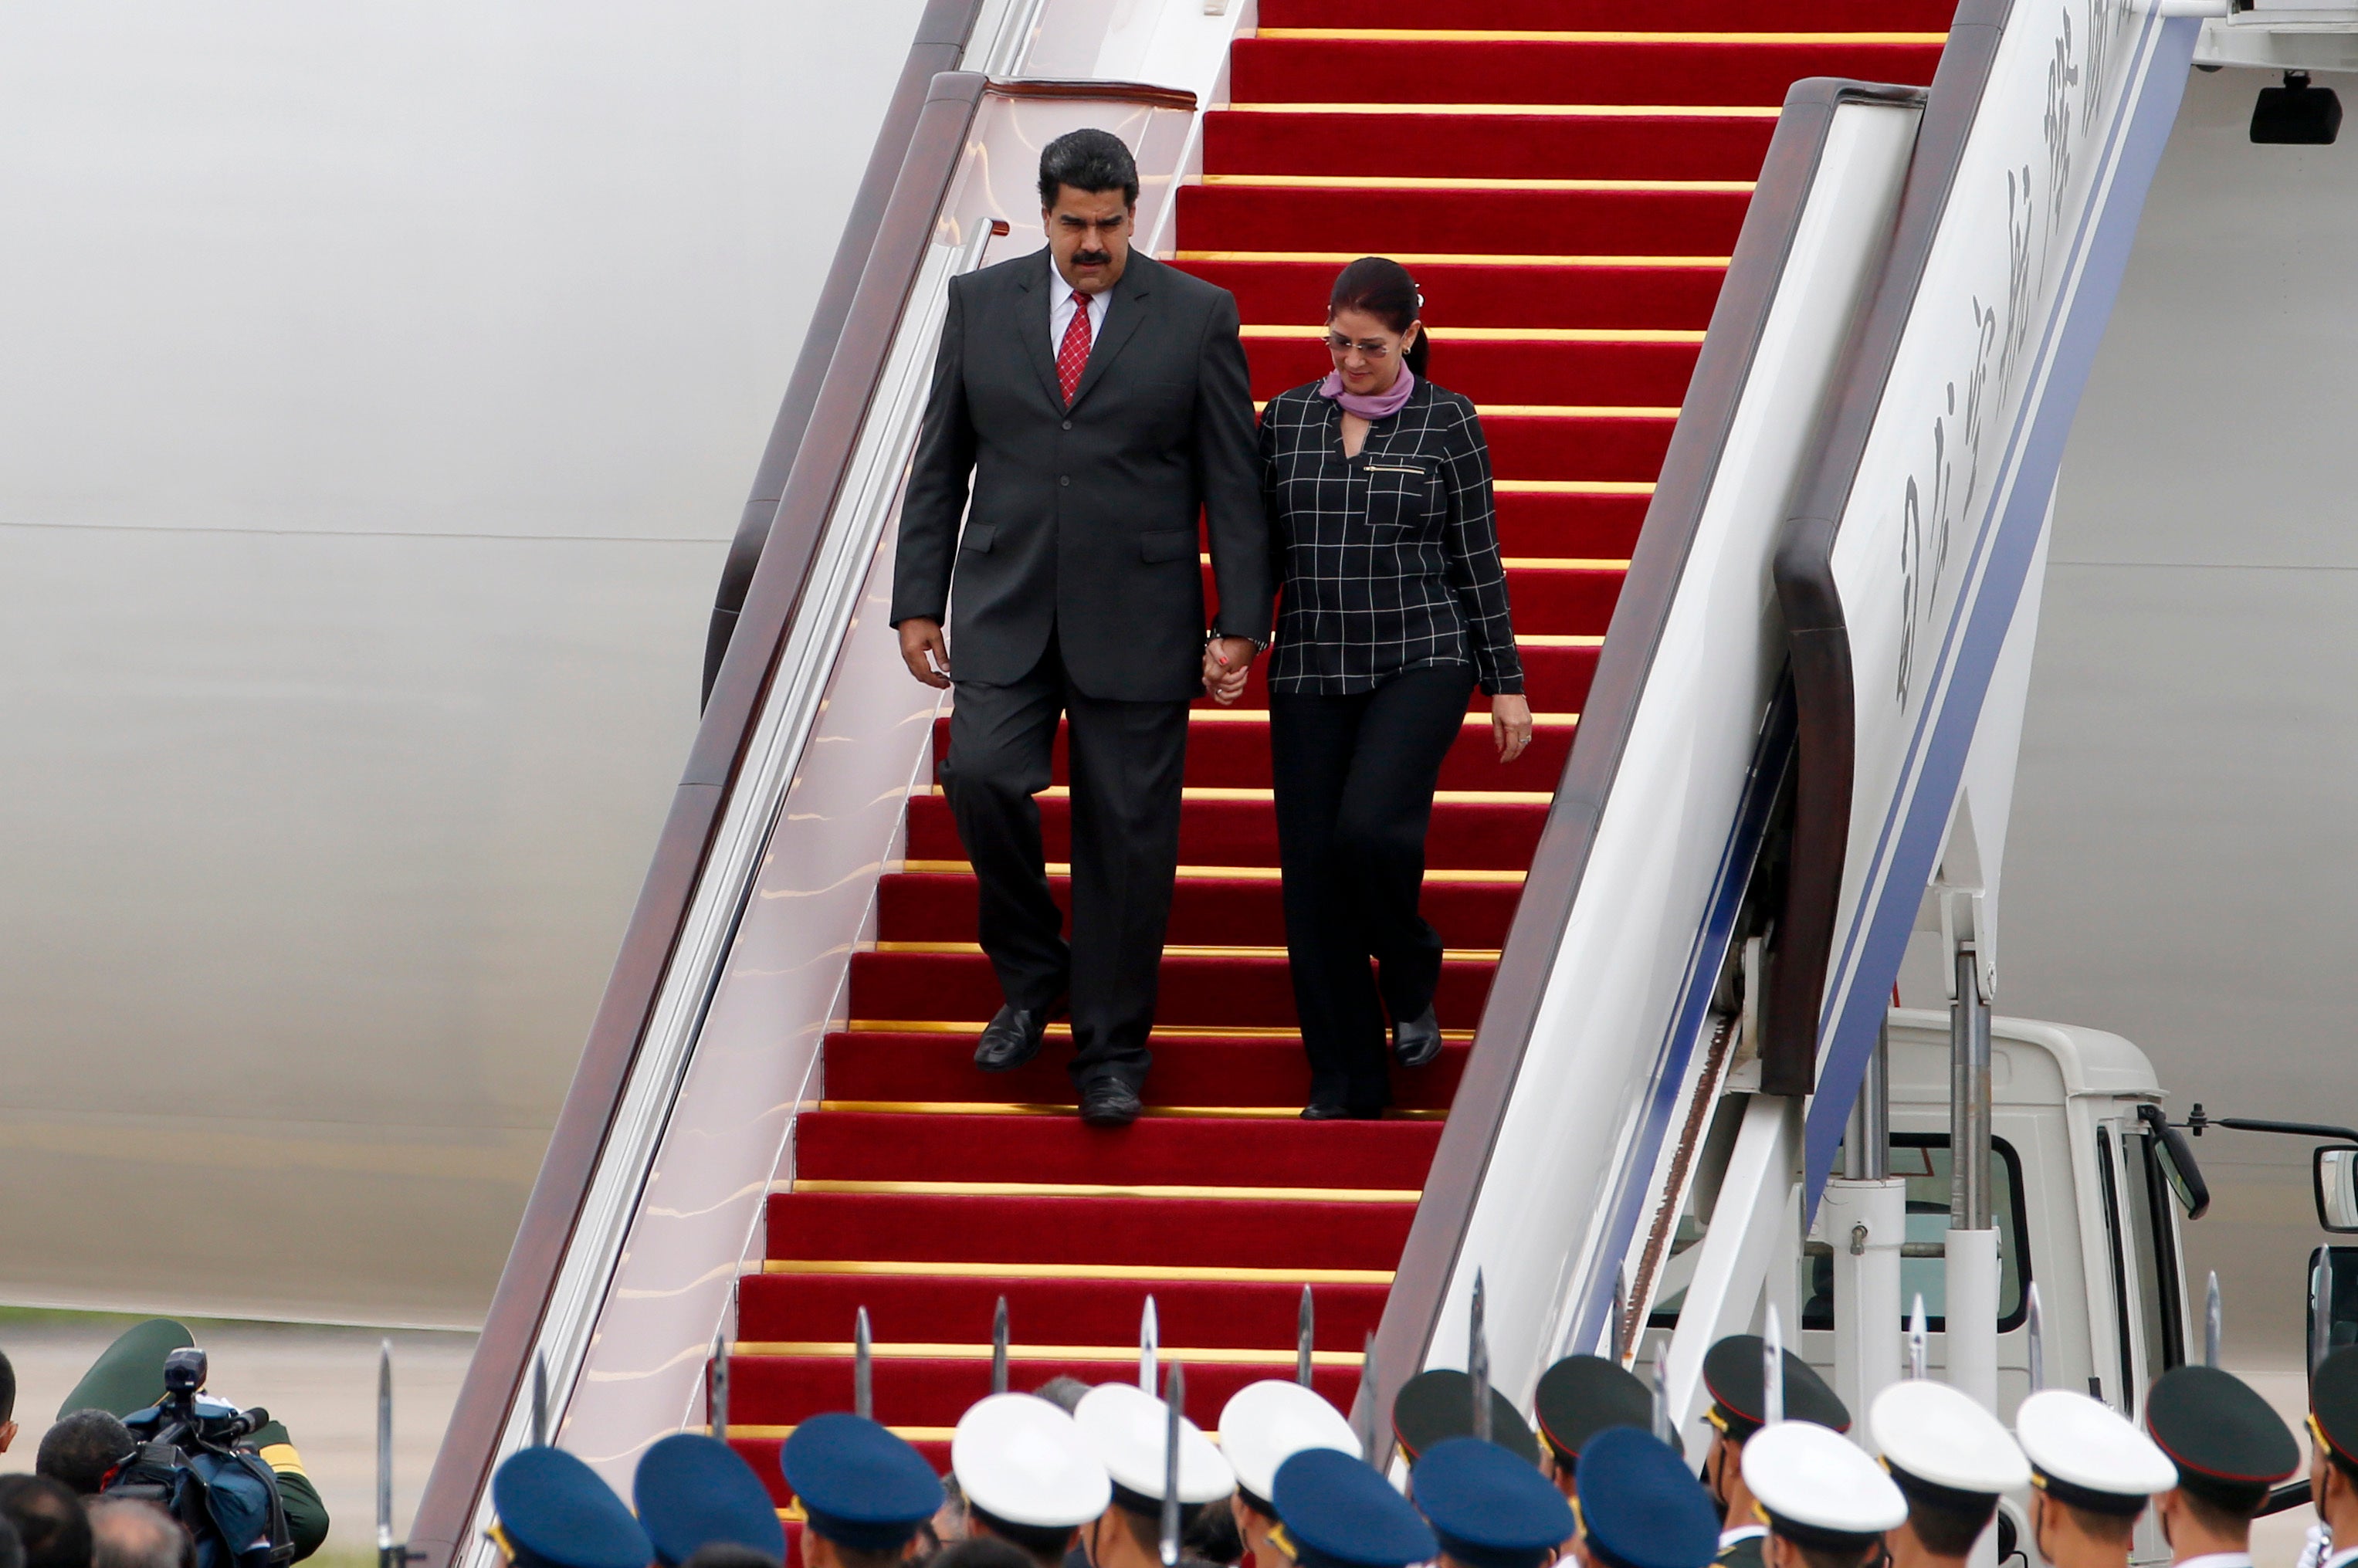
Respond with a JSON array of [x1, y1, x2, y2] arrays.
[[941, 637, 1188, 1089]]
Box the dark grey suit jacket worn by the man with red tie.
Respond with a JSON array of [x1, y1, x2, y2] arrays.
[[891, 250, 1273, 703]]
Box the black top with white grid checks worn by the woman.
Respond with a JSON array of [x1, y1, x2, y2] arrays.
[[1259, 380, 1523, 696]]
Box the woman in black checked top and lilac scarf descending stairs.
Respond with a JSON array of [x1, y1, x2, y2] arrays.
[[1205, 257, 1530, 1120]]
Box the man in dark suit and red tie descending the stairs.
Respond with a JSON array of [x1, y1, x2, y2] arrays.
[[891, 130, 1273, 1127]]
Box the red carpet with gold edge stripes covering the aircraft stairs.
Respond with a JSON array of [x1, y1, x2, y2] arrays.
[[731, 0, 1948, 1507]]
